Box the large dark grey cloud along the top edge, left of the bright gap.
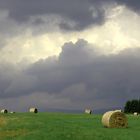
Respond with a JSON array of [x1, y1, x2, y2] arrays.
[[0, 0, 104, 30]]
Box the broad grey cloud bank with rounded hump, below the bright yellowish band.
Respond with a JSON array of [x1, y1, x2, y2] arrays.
[[0, 39, 140, 110]]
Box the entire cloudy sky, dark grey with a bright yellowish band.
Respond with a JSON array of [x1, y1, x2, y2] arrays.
[[0, 0, 140, 111]]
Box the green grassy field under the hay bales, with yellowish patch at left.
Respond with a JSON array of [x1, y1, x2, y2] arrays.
[[0, 113, 140, 140]]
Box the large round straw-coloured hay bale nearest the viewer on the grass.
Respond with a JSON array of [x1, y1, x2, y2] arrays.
[[102, 111, 128, 128]]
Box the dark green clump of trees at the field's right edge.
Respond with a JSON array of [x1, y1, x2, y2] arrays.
[[124, 99, 140, 113]]
